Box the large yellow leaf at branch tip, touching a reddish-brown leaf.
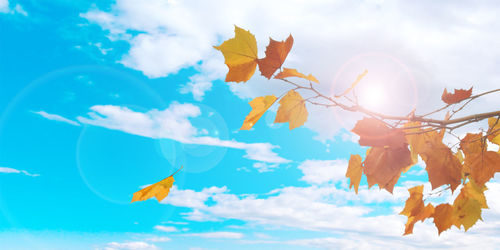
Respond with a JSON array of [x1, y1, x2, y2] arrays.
[[214, 25, 257, 82]]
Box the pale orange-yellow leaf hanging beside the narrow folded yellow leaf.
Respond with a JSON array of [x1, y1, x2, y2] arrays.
[[274, 89, 308, 130]]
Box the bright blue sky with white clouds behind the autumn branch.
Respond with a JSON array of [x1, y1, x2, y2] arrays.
[[0, 0, 500, 250]]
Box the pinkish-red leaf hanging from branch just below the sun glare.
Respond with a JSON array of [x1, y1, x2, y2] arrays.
[[351, 118, 407, 148]]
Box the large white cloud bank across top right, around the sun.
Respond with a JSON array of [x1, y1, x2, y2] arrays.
[[81, 0, 500, 143]]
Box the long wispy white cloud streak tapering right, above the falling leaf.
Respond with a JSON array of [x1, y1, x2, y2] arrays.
[[77, 103, 289, 163]]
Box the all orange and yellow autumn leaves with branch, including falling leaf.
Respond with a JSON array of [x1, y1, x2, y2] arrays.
[[133, 26, 500, 235]]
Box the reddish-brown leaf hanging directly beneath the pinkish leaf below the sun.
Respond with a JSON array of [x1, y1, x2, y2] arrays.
[[363, 147, 411, 193]]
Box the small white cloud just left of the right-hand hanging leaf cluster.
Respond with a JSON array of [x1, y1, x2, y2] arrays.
[[298, 160, 347, 184]]
